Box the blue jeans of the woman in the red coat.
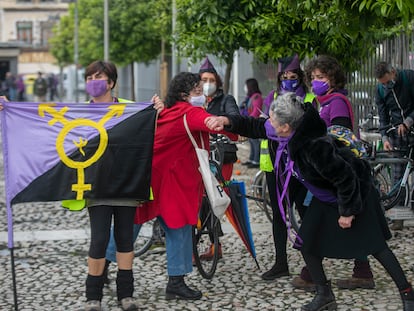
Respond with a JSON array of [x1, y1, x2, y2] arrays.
[[106, 217, 193, 276]]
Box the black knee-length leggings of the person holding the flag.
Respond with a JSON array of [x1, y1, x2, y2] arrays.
[[88, 205, 136, 259]]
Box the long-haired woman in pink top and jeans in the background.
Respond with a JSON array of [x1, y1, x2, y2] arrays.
[[240, 78, 263, 168]]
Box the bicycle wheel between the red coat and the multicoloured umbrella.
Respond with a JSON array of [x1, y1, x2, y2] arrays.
[[193, 198, 219, 279]]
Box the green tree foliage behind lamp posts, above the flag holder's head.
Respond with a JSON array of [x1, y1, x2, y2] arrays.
[[50, 0, 171, 66]]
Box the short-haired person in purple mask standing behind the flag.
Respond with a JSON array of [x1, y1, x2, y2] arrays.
[[80, 61, 138, 311]]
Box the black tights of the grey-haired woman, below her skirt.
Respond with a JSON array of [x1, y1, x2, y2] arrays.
[[302, 246, 410, 291]]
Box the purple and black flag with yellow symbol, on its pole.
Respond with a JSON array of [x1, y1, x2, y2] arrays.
[[1, 102, 156, 310]]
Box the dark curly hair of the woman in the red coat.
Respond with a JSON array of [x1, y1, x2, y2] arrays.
[[165, 72, 200, 108]]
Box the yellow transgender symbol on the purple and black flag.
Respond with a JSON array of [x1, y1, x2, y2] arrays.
[[38, 103, 126, 200]]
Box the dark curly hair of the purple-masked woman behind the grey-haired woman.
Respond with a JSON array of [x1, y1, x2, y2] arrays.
[[305, 55, 346, 90]]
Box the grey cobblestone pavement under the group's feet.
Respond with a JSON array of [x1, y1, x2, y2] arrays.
[[0, 144, 414, 311]]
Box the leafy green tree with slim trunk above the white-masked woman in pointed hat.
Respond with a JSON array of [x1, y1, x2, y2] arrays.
[[175, 0, 261, 91]]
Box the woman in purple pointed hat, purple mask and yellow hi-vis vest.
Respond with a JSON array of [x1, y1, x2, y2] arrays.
[[260, 54, 317, 281]]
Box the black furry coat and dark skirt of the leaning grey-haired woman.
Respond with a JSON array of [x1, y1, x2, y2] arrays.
[[226, 106, 391, 258]]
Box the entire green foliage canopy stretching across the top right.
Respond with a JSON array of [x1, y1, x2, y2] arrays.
[[176, 0, 414, 74]]
